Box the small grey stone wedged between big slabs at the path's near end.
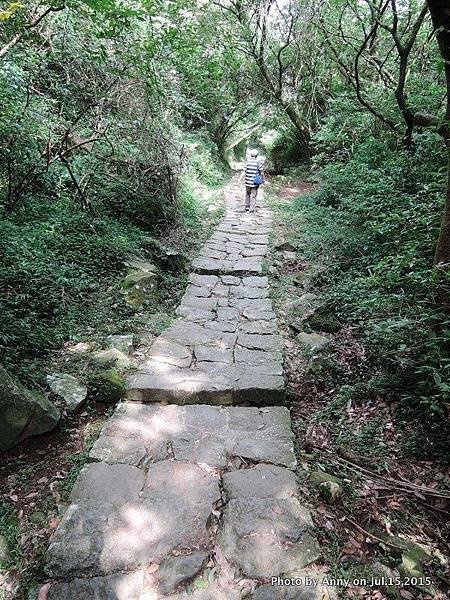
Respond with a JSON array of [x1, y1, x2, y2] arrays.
[[157, 551, 208, 594]]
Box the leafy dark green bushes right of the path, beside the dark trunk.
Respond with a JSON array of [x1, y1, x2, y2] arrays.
[[288, 127, 450, 454]]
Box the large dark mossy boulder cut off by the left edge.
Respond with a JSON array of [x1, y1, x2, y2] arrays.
[[0, 366, 59, 450]]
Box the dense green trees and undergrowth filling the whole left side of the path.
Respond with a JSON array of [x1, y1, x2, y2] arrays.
[[0, 2, 236, 381]]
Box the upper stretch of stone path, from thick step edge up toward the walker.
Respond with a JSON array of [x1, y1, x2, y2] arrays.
[[127, 183, 284, 405]]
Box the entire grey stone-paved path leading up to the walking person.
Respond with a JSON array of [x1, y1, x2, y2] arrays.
[[45, 178, 323, 600]]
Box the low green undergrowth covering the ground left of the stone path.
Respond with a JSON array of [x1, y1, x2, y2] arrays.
[[0, 135, 224, 385]]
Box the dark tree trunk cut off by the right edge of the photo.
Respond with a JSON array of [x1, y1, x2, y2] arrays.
[[428, 0, 450, 270]]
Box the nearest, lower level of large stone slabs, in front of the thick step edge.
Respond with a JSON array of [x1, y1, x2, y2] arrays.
[[45, 402, 319, 600]]
